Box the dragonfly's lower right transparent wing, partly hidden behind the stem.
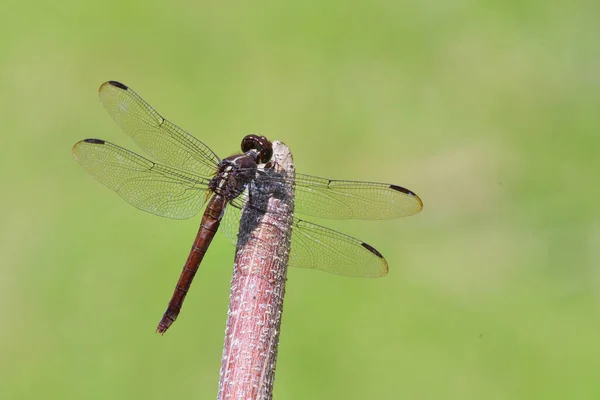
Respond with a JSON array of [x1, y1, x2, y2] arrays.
[[220, 202, 388, 278]]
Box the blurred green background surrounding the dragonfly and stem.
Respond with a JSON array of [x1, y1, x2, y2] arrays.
[[0, 1, 600, 399]]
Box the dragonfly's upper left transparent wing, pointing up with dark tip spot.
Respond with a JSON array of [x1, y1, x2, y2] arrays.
[[98, 81, 219, 176]]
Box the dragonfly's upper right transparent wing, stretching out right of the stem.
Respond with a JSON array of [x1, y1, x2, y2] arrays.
[[294, 174, 423, 219]]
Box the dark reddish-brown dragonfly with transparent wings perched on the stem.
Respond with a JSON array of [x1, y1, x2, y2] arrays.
[[72, 81, 423, 334]]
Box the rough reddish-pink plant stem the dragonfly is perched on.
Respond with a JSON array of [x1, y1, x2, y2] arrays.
[[218, 141, 294, 400]]
